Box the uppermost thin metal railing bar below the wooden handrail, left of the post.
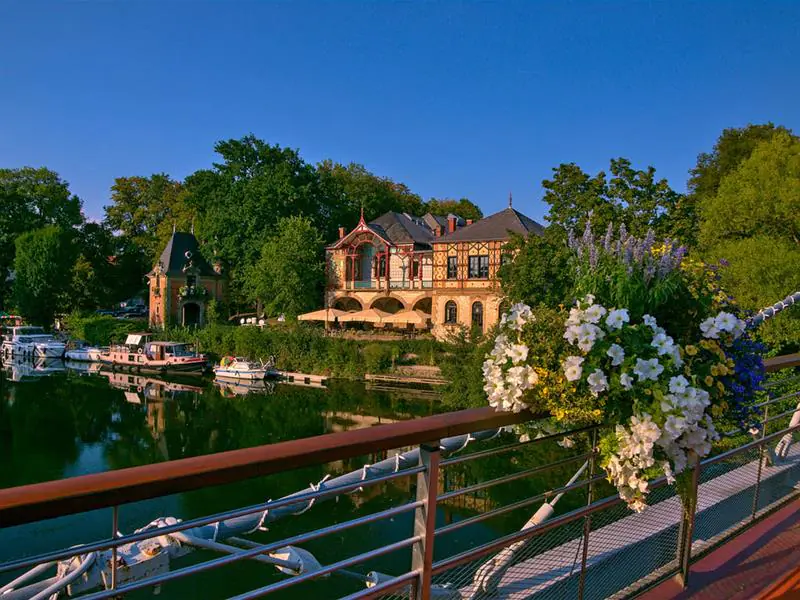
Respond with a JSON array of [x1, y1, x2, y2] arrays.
[[0, 466, 425, 573]]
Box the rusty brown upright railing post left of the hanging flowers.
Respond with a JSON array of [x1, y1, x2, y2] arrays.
[[411, 440, 441, 600]]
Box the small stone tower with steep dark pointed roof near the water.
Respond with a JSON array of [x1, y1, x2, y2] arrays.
[[147, 232, 227, 328]]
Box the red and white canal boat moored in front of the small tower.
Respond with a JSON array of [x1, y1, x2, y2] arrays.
[[100, 333, 208, 375]]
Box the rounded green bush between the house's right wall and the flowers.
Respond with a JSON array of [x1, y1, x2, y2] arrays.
[[500, 225, 574, 306]]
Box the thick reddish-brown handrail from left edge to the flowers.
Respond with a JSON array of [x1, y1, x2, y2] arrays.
[[0, 406, 541, 526]]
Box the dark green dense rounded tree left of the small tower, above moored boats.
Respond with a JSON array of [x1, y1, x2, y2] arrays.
[[14, 225, 75, 325]]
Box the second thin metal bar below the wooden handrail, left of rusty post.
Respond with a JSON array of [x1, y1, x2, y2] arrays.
[[73, 500, 424, 600]]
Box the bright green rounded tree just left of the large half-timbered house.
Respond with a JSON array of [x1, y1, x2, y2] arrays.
[[247, 217, 325, 316]]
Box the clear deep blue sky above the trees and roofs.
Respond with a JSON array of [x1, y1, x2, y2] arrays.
[[0, 0, 800, 223]]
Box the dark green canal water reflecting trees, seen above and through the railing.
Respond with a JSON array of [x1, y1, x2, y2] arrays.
[[0, 361, 584, 598]]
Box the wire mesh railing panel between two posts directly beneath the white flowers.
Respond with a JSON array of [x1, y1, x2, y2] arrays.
[[580, 486, 681, 599]]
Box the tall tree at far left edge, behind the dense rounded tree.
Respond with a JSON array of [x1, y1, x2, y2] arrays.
[[0, 167, 83, 308]]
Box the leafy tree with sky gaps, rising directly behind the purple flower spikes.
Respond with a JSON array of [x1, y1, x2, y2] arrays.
[[542, 158, 681, 235]]
